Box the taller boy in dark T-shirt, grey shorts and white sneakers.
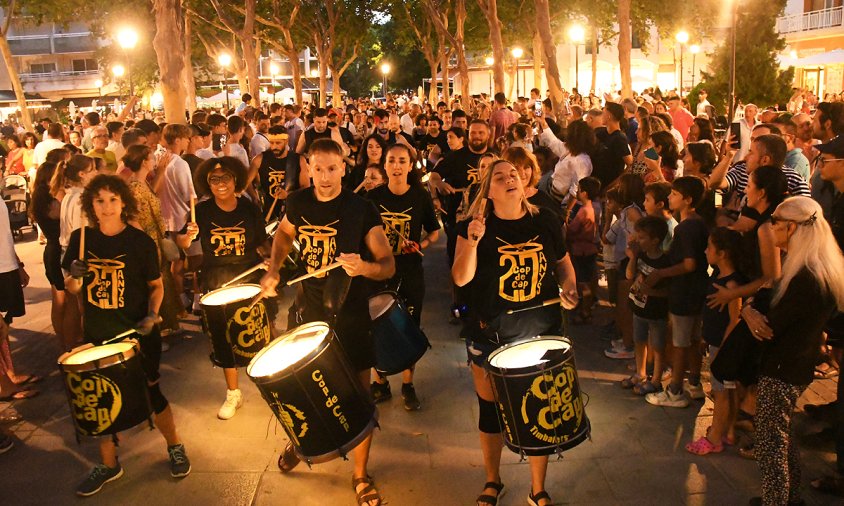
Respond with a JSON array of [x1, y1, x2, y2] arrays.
[[645, 176, 709, 408]]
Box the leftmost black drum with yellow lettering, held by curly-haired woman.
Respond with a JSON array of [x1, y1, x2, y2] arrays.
[[59, 339, 152, 436]]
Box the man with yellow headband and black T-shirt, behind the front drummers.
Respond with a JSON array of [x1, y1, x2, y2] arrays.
[[246, 125, 292, 221]]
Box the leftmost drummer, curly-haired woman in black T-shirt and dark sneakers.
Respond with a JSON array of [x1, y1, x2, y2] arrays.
[[62, 174, 191, 496]]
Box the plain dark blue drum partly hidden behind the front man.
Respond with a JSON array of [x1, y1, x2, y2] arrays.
[[369, 292, 431, 376]]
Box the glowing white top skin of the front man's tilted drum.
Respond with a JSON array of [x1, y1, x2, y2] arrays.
[[246, 322, 329, 378]]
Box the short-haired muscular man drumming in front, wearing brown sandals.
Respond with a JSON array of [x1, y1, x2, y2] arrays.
[[261, 139, 395, 506]]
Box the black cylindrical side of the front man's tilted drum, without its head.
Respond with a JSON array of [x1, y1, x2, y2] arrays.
[[247, 330, 378, 463]]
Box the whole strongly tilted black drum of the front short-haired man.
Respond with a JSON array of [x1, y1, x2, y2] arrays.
[[246, 322, 378, 464]]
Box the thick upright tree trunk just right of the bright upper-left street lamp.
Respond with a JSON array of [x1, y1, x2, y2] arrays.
[[152, 0, 187, 124]]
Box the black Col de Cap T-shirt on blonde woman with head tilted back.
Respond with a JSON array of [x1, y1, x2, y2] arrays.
[[457, 208, 566, 342]]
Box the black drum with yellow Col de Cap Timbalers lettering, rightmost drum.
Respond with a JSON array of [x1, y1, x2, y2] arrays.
[[485, 336, 591, 455]]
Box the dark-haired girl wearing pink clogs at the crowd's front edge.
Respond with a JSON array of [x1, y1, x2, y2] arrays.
[[686, 227, 745, 455]]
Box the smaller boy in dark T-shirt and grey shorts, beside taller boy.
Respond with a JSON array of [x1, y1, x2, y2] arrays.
[[621, 216, 671, 395]]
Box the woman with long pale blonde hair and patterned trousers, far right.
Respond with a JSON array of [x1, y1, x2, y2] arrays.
[[742, 197, 844, 505]]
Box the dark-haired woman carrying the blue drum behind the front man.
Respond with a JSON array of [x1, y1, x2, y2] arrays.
[[366, 144, 440, 411]]
